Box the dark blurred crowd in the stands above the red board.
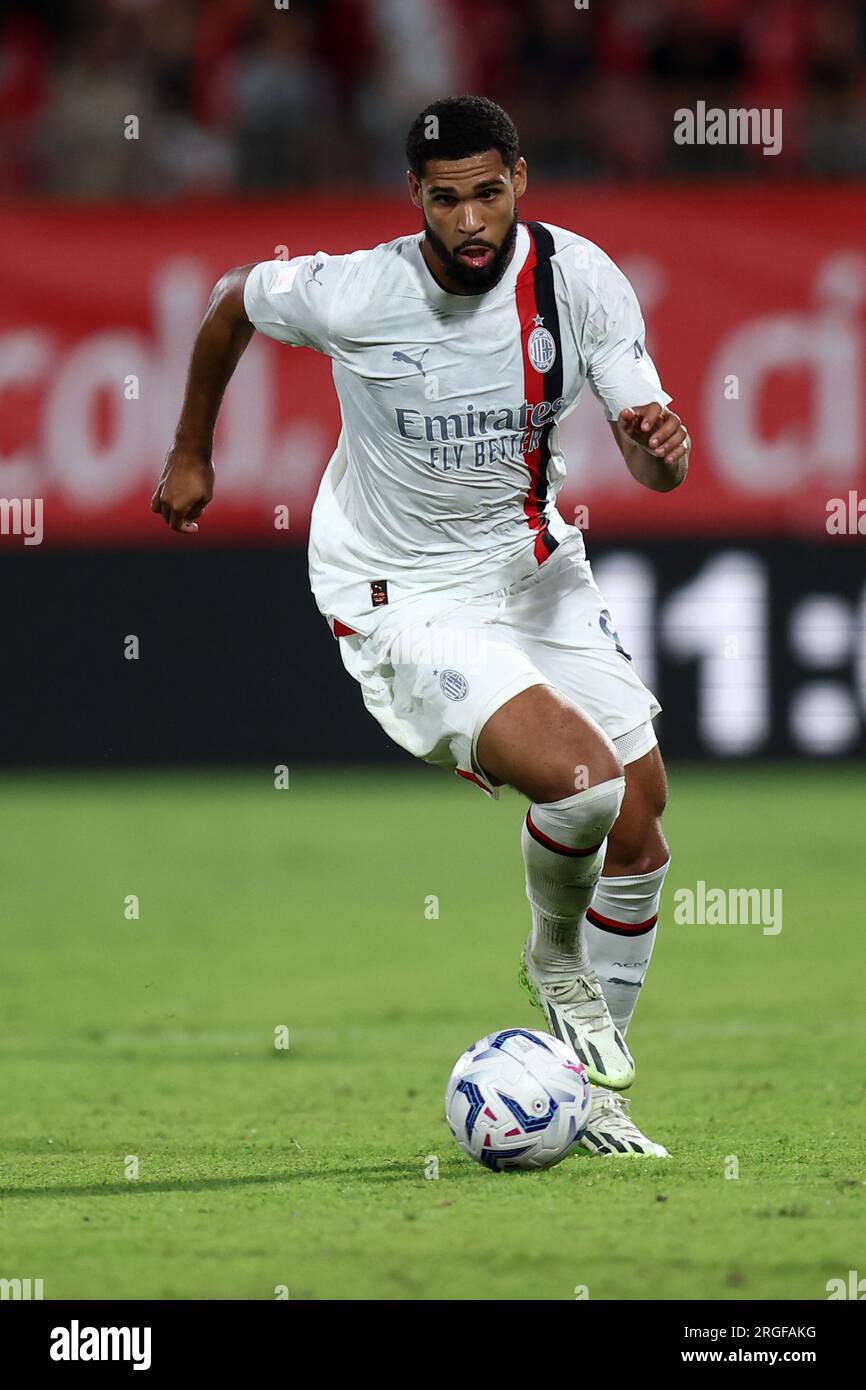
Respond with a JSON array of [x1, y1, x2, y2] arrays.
[[0, 0, 866, 199]]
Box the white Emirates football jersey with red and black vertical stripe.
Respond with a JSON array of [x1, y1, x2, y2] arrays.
[[245, 222, 671, 632]]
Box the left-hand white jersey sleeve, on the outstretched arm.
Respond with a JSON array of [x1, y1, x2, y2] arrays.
[[243, 252, 346, 354]]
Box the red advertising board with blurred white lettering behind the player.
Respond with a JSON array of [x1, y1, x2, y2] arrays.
[[0, 186, 866, 546]]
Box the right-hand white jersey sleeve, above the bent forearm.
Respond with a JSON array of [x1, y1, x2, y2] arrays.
[[584, 257, 673, 420]]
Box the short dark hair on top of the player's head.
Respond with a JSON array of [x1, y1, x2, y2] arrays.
[[406, 96, 520, 178]]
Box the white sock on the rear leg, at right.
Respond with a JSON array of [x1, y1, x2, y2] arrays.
[[584, 859, 670, 1036]]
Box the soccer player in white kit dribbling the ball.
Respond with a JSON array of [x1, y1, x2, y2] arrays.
[[152, 96, 689, 1156]]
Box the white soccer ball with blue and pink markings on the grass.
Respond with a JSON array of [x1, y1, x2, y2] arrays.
[[445, 1029, 591, 1172]]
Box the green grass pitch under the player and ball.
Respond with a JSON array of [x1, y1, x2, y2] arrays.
[[0, 766, 866, 1300]]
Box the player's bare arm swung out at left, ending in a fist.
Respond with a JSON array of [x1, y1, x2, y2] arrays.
[[150, 265, 254, 532]]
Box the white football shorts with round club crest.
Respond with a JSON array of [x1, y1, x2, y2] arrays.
[[339, 537, 662, 796]]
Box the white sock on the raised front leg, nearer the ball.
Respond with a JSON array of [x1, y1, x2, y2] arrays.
[[521, 777, 626, 979]]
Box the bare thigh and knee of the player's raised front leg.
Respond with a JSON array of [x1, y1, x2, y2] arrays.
[[475, 685, 623, 802]]
